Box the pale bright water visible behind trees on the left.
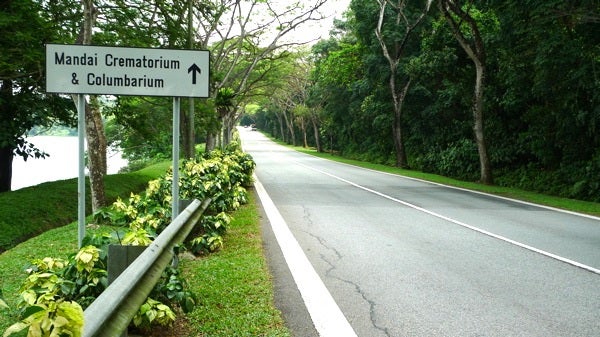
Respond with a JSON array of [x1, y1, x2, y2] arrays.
[[12, 136, 127, 191]]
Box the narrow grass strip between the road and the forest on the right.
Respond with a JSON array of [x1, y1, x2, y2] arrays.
[[287, 145, 600, 216]]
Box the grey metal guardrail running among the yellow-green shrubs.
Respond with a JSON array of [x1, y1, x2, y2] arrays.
[[82, 199, 210, 337]]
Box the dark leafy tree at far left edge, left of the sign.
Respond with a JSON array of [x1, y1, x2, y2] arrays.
[[0, 0, 73, 192]]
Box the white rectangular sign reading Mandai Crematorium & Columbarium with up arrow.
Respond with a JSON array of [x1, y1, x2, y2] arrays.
[[46, 44, 210, 97]]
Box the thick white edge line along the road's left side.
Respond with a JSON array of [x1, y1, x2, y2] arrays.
[[254, 175, 357, 337]]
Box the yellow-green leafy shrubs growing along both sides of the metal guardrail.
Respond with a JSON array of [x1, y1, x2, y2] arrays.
[[0, 143, 254, 336]]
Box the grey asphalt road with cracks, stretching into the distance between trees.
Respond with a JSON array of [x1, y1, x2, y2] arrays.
[[240, 129, 600, 337]]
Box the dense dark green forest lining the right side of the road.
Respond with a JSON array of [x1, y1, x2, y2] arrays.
[[250, 0, 600, 201]]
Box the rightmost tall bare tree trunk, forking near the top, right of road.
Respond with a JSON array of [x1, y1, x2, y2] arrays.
[[438, 0, 494, 184]]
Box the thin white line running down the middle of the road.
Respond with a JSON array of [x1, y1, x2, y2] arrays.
[[296, 161, 600, 275]]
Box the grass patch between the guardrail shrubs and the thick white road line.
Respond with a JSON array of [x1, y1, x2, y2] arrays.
[[183, 190, 290, 337]]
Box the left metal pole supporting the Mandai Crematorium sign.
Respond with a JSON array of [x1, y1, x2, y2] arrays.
[[77, 94, 85, 248]]
